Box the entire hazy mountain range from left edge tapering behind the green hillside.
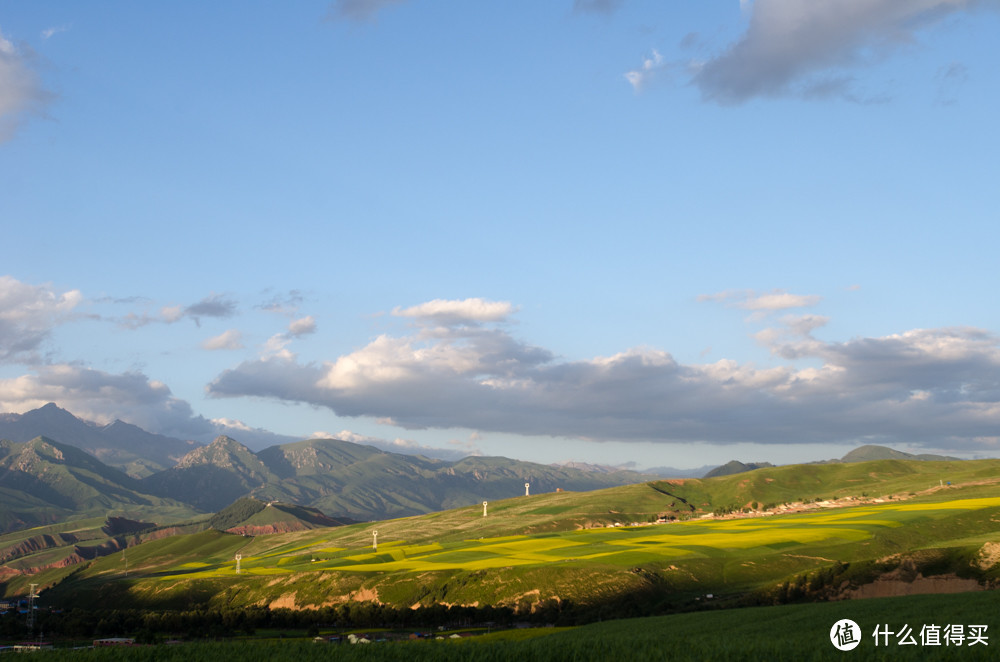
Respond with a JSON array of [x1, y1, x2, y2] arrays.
[[0, 404, 657, 531]]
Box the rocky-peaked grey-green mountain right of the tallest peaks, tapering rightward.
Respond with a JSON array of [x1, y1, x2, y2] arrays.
[[141, 436, 668, 520]]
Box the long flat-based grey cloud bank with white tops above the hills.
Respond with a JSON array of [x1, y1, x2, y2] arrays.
[[209, 298, 1000, 450]]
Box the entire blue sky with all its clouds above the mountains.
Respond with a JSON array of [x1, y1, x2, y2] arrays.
[[0, 0, 1000, 474]]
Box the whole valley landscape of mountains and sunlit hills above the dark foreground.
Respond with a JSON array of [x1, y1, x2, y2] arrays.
[[0, 410, 1000, 660]]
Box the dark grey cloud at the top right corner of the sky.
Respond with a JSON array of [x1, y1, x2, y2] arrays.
[[692, 0, 995, 105]]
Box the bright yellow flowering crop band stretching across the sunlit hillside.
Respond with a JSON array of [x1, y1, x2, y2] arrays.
[[127, 497, 1000, 580]]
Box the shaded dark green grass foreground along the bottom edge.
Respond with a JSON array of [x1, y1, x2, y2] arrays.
[[39, 591, 1000, 662]]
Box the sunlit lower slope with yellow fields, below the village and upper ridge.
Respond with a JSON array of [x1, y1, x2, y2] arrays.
[[21, 486, 1000, 607]]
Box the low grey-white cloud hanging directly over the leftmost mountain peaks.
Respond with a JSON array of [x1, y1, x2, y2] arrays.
[[0, 364, 215, 439]]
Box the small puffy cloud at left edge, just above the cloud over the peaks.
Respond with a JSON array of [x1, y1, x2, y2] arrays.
[[0, 276, 83, 366]]
